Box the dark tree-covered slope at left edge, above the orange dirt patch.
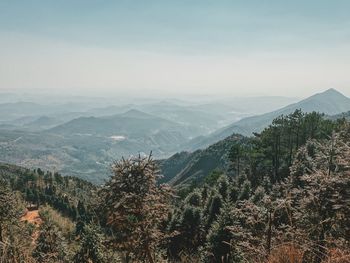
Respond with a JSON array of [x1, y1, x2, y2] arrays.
[[0, 163, 97, 223]]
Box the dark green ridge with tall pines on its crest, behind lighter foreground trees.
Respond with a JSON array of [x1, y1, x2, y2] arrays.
[[160, 110, 342, 185]]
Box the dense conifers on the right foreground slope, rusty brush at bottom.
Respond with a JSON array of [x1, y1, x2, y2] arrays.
[[162, 114, 350, 262]]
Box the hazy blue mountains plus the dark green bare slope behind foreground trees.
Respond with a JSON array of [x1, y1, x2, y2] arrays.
[[0, 89, 350, 183]]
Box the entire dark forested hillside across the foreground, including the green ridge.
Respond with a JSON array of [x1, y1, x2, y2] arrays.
[[0, 110, 350, 263]]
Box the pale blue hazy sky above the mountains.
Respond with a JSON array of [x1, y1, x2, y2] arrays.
[[0, 0, 350, 97]]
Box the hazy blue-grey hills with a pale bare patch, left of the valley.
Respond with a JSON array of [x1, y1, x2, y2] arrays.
[[0, 110, 196, 182]]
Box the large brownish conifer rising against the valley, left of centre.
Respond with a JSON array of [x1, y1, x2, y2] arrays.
[[101, 156, 171, 263]]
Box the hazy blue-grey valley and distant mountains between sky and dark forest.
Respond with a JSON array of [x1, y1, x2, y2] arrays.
[[0, 89, 350, 182]]
